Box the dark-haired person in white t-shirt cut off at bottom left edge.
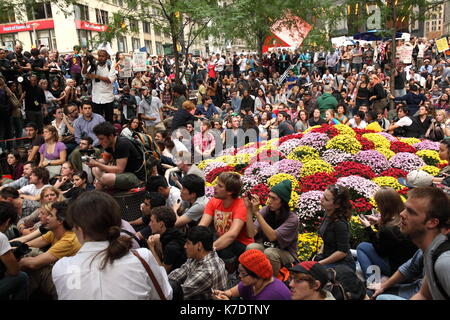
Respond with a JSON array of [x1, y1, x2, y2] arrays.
[[0, 201, 28, 300]]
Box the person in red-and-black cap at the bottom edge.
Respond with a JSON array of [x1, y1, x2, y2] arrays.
[[289, 261, 336, 300]]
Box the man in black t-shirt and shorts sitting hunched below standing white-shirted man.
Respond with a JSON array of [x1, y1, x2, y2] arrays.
[[86, 122, 146, 190]]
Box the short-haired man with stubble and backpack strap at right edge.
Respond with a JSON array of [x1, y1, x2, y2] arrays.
[[388, 187, 450, 300]]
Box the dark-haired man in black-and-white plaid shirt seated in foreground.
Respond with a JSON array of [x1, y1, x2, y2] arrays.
[[169, 226, 228, 300]]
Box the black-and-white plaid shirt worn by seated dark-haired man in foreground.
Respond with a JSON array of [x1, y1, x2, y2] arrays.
[[169, 251, 228, 300]]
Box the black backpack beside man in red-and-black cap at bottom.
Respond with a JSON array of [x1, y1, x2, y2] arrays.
[[324, 265, 366, 300]]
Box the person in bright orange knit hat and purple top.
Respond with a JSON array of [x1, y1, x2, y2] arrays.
[[214, 249, 291, 300]]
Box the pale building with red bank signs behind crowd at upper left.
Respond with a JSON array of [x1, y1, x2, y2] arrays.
[[0, 0, 185, 55]]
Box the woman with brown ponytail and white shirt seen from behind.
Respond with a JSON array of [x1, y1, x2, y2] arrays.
[[52, 191, 172, 300]]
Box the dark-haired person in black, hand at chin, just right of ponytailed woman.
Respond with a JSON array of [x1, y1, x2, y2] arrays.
[[147, 206, 187, 273]]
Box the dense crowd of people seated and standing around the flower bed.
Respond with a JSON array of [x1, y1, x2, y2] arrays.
[[0, 38, 450, 300]]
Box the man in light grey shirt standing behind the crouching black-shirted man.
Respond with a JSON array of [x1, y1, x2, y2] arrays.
[[138, 86, 166, 138]]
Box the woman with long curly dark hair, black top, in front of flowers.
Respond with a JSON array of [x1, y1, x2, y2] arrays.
[[314, 185, 356, 271]]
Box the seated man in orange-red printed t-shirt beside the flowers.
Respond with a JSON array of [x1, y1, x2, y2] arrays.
[[199, 172, 253, 271]]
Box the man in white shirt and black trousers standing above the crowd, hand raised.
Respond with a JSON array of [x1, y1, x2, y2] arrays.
[[81, 50, 117, 123]]
